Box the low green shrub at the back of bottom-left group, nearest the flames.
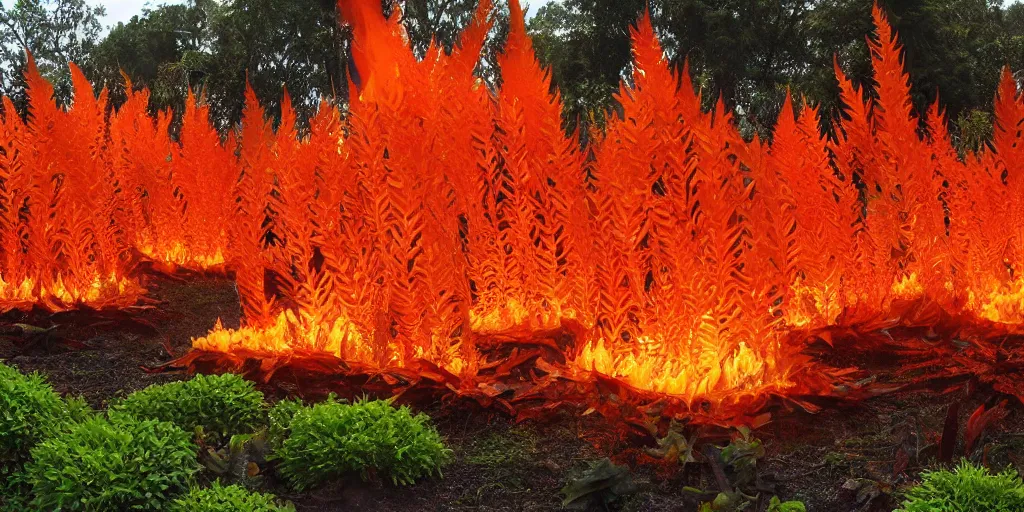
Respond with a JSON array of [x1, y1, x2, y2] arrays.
[[111, 374, 265, 440]]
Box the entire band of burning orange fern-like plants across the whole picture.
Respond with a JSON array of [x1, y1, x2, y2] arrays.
[[6, 0, 1024, 423]]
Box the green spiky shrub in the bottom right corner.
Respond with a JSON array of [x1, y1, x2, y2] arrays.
[[898, 461, 1024, 512]]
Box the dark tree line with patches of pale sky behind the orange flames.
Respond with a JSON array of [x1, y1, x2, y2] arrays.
[[0, 0, 1024, 150]]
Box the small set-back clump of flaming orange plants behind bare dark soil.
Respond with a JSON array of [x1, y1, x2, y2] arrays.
[[110, 83, 239, 270]]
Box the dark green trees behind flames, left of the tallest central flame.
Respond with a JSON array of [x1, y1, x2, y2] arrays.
[[93, 0, 347, 129]]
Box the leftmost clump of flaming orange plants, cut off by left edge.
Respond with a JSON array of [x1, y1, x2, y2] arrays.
[[0, 55, 140, 310]]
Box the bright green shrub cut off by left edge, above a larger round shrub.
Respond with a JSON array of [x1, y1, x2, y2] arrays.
[[0, 364, 92, 480]]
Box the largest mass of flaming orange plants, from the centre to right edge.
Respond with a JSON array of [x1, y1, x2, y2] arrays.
[[178, 1, 1024, 402]]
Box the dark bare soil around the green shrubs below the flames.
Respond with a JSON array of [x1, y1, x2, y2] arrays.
[[0, 276, 1024, 512]]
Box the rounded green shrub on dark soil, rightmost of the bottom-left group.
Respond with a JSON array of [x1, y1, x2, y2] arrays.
[[272, 400, 451, 490]]
